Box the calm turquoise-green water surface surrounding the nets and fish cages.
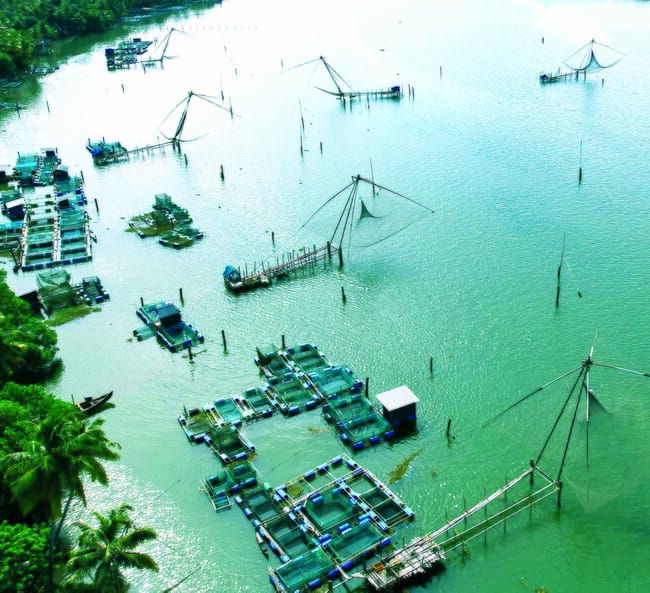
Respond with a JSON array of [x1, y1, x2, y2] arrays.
[[0, 0, 650, 593]]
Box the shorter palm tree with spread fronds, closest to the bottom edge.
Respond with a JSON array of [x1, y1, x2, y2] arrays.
[[66, 503, 158, 593]]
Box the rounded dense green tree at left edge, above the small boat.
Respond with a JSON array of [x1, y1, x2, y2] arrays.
[[0, 271, 60, 387]]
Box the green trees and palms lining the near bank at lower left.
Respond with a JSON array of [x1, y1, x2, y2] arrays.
[[0, 234, 159, 593]]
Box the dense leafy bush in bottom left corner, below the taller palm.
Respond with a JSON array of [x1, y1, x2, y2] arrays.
[[0, 521, 50, 593]]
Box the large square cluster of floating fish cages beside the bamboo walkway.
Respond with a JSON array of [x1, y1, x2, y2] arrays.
[[253, 456, 415, 591]]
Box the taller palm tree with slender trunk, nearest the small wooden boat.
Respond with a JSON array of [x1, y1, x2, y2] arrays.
[[2, 414, 119, 590]]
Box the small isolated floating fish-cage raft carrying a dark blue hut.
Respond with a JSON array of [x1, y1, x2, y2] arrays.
[[133, 301, 205, 352]]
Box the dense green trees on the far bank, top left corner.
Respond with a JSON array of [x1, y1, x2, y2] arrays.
[[0, 0, 221, 81]]
